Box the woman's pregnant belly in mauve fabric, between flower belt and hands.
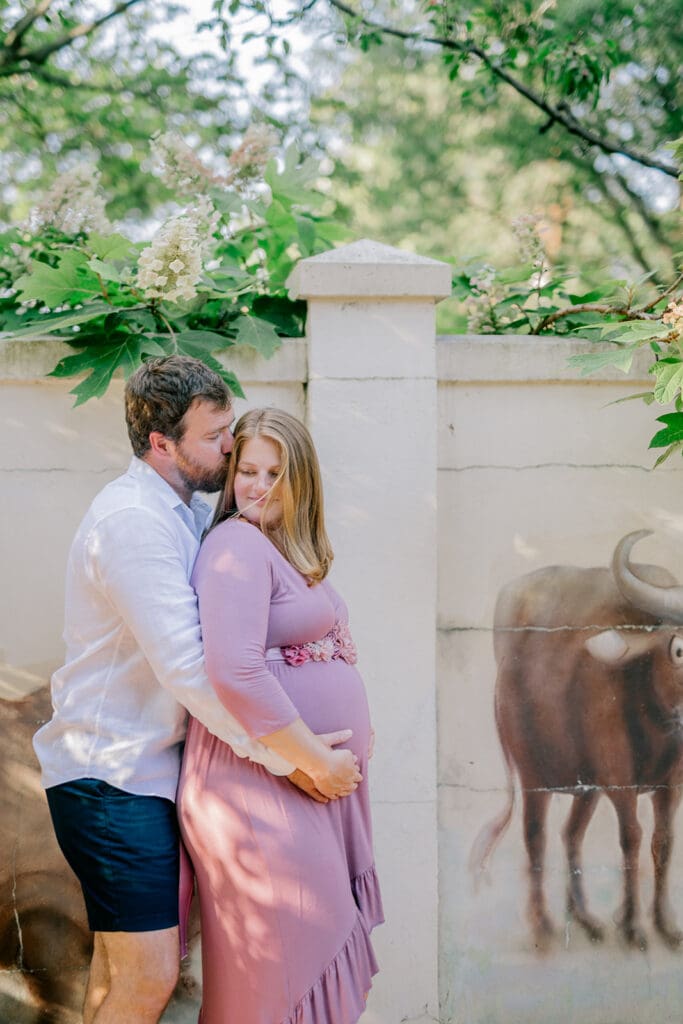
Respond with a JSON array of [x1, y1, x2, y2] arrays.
[[268, 659, 370, 758]]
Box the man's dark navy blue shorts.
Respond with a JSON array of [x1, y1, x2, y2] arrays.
[[46, 778, 179, 932]]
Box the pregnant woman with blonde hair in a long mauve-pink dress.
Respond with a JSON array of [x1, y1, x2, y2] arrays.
[[178, 409, 383, 1024]]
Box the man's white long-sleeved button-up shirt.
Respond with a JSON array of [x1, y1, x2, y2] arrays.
[[34, 458, 292, 800]]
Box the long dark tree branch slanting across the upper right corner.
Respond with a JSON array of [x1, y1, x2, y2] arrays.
[[330, 0, 679, 178]]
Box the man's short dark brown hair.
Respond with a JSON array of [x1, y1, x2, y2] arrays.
[[125, 355, 230, 458]]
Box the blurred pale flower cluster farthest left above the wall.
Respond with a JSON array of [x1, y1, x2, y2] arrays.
[[29, 164, 112, 234]]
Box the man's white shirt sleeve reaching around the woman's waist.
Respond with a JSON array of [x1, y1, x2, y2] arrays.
[[85, 508, 293, 775]]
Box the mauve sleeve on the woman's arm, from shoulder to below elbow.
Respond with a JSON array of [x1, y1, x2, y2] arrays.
[[194, 522, 299, 739]]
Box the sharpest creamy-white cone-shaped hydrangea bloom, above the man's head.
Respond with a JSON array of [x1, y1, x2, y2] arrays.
[[136, 215, 203, 302]]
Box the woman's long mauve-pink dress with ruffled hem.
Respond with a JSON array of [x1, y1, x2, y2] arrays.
[[178, 520, 383, 1024]]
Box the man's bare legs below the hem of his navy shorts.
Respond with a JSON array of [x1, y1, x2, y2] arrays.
[[83, 928, 179, 1024]]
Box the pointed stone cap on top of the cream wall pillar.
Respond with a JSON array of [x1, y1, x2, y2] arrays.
[[287, 239, 452, 299]]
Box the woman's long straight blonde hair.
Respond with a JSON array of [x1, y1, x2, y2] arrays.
[[212, 409, 334, 583]]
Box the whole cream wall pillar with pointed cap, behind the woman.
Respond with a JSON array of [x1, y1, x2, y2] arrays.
[[289, 241, 451, 1024]]
